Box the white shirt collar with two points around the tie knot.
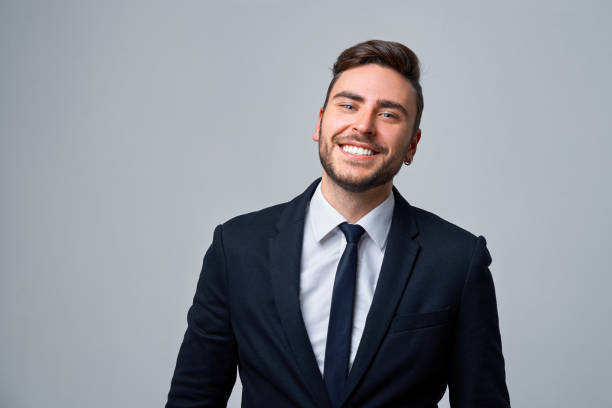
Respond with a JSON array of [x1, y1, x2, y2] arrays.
[[309, 183, 395, 250]]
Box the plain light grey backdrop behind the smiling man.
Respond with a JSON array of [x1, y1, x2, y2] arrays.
[[0, 0, 612, 408]]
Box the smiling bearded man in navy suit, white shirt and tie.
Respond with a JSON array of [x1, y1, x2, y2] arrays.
[[167, 41, 510, 408]]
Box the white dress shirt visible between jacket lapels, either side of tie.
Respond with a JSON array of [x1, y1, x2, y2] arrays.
[[300, 183, 395, 374]]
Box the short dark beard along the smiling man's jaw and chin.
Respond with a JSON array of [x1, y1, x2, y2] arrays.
[[319, 129, 407, 193]]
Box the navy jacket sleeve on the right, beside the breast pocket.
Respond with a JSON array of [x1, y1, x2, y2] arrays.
[[449, 237, 510, 408]]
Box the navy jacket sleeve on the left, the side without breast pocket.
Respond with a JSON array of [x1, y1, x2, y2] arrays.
[[166, 226, 238, 408]]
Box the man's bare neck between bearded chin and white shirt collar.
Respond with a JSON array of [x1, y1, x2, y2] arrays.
[[321, 171, 393, 224]]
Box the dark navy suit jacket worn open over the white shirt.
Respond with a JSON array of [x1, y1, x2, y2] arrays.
[[166, 180, 510, 408]]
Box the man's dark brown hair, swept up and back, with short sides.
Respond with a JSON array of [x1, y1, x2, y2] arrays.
[[323, 40, 423, 132]]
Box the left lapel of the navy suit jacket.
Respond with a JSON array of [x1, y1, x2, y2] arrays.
[[269, 180, 330, 407]]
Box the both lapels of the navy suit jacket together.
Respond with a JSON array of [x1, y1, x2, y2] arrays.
[[269, 179, 419, 407]]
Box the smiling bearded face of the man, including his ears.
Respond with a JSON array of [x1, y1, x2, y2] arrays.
[[313, 64, 421, 192]]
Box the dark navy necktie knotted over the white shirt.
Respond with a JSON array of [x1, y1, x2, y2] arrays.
[[323, 222, 365, 407]]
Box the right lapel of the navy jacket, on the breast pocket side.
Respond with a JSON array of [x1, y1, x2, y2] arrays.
[[343, 187, 419, 400]]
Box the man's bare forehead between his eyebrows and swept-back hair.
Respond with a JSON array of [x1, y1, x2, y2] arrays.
[[330, 64, 416, 111]]
